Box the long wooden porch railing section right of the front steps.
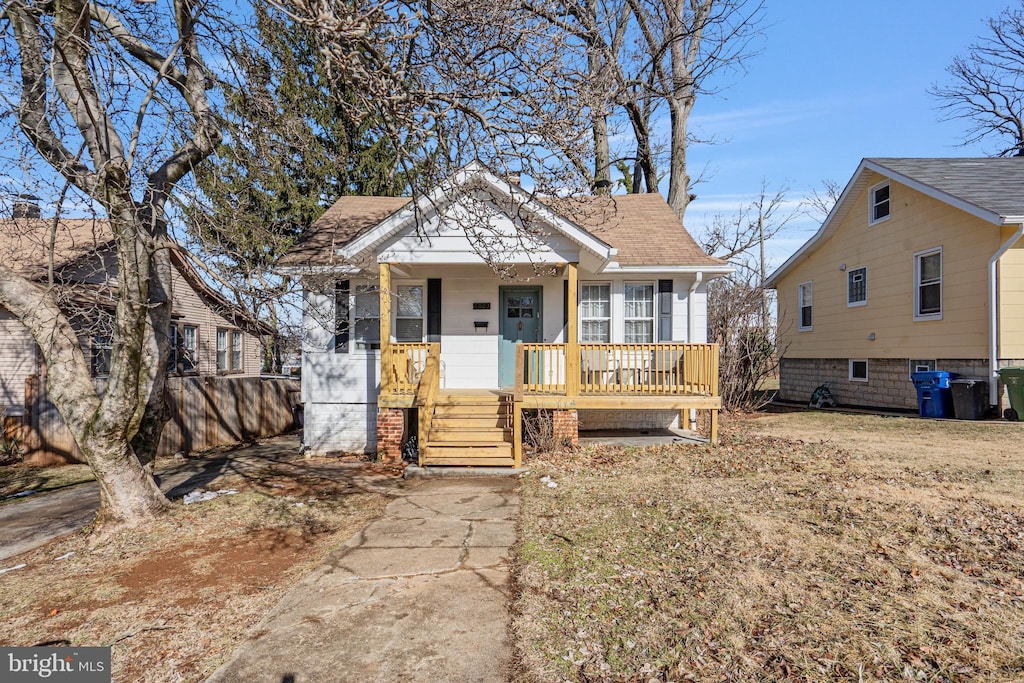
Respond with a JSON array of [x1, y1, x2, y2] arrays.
[[517, 343, 719, 396]]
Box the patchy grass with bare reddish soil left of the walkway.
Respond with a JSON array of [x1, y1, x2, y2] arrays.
[[0, 460, 395, 682]]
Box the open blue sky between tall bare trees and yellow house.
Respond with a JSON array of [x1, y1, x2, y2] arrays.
[[685, 0, 1020, 271]]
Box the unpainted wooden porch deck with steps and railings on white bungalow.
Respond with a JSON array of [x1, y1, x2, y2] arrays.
[[378, 343, 722, 467]]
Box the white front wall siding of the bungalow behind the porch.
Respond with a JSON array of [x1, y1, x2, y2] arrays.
[[302, 264, 708, 453]]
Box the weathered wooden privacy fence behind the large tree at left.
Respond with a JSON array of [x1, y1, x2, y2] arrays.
[[19, 377, 299, 465]]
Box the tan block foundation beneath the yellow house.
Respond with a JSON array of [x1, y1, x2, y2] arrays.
[[778, 357, 1019, 411]]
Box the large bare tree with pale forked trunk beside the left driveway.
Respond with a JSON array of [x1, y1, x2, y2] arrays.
[[0, 0, 220, 525]]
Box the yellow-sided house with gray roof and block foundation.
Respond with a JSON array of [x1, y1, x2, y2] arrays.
[[767, 158, 1024, 409]]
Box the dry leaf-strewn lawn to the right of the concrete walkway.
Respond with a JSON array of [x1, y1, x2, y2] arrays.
[[513, 413, 1024, 681]]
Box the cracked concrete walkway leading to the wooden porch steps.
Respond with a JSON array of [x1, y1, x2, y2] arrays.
[[208, 477, 519, 683]]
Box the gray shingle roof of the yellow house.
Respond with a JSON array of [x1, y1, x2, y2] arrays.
[[866, 157, 1024, 218]]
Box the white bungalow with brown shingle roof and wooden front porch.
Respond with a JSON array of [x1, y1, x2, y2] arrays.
[[280, 164, 731, 466]]
